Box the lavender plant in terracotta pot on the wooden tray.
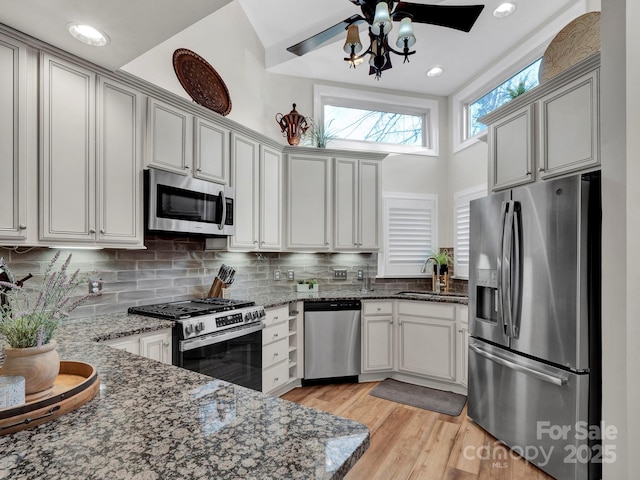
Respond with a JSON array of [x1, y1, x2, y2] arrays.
[[0, 251, 92, 402]]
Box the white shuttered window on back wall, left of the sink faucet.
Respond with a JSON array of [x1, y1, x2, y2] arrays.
[[378, 194, 438, 278]]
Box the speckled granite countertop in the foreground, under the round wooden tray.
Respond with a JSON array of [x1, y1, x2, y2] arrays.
[[0, 314, 369, 480]]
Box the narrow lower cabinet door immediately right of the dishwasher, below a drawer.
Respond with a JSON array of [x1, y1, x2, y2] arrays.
[[362, 315, 393, 373]]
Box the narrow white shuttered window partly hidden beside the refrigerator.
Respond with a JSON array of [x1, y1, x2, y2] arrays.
[[453, 184, 487, 278]]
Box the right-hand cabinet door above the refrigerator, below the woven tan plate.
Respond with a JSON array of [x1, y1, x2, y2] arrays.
[[538, 70, 600, 178]]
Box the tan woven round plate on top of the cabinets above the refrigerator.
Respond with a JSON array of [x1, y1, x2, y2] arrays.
[[538, 12, 600, 83]]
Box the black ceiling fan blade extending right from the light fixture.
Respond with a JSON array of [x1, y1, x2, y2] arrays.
[[391, 2, 484, 32]]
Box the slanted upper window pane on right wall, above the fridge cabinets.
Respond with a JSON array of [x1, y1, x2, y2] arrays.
[[467, 58, 542, 138]]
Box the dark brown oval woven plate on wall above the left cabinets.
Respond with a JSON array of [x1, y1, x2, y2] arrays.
[[173, 48, 231, 115]]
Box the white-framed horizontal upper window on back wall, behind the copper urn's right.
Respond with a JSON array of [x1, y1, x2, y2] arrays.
[[314, 85, 438, 156]]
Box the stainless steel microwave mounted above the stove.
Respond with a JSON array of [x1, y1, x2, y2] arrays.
[[145, 168, 235, 235]]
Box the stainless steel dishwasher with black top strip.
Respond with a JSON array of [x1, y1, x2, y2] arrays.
[[302, 300, 361, 385]]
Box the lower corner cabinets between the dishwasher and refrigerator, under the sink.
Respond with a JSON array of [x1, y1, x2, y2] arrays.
[[362, 300, 468, 388]]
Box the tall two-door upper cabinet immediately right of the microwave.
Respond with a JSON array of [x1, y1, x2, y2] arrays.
[[229, 133, 283, 250]]
